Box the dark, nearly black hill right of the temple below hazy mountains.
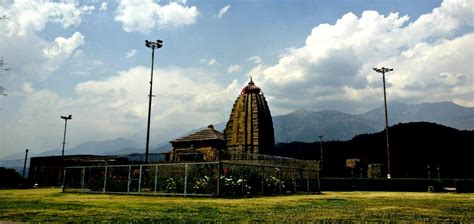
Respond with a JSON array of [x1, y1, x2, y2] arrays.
[[276, 122, 474, 178]]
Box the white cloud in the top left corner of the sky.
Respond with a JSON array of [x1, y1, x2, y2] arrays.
[[0, 1, 94, 93]]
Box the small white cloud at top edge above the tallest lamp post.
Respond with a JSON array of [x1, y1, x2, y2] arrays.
[[115, 0, 199, 34]]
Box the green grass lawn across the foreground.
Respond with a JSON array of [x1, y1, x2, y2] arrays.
[[0, 189, 474, 222]]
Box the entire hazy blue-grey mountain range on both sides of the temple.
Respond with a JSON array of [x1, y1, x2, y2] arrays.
[[0, 101, 474, 166]]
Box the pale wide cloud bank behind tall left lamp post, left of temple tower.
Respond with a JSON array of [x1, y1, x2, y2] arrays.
[[2, 66, 240, 154]]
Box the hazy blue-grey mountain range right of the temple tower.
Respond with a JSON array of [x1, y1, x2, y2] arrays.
[[273, 101, 474, 143]]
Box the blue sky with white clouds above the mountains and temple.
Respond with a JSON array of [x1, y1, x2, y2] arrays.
[[0, 0, 474, 158]]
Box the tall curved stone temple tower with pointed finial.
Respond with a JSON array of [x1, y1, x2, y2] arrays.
[[224, 78, 275, 155]]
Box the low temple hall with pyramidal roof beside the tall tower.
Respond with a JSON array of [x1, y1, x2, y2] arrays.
[[169, 125, 225, 162]]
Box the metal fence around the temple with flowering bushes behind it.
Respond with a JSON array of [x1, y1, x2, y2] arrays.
[[63, 161, 319, 197]]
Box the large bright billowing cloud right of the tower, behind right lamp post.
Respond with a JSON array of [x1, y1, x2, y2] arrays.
[[249, 1, 474, 113]]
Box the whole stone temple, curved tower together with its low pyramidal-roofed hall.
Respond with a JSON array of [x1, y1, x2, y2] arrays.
[[169, 78, 275, 161]]
